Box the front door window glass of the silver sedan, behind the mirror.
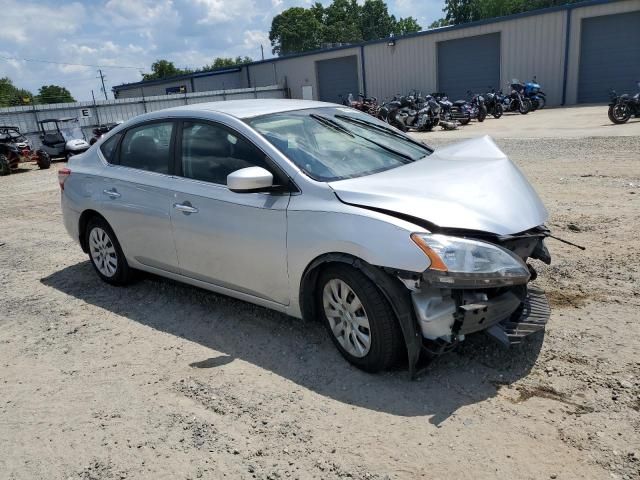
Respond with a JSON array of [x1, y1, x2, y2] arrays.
[[182, 122, 270, 185]]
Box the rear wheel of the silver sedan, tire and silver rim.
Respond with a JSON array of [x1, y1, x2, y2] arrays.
[[85, 217, 132, 285]]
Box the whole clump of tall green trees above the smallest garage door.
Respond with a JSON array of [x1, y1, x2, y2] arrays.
[[269, 0, 421, 55]]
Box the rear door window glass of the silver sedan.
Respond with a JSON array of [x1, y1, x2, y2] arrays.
[[120, 122, 173, 173]]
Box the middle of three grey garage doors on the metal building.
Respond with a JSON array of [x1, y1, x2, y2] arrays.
[[438, 33, 502, 100]]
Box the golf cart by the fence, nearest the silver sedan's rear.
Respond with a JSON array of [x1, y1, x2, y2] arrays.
[[40, 117, 89, 161]]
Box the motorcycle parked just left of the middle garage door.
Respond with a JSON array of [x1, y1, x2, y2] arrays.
[[380, 92, 440, 132]]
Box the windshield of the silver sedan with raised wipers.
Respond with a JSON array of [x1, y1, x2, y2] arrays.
[[247, 107, 433, 182]]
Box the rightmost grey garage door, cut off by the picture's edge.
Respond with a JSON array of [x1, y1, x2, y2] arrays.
[[578, 12, 640, 103]]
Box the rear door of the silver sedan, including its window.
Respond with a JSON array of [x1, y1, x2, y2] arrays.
[[97, 120, 178, 273]]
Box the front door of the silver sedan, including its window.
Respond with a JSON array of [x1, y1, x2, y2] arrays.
[[171, 121, 289, 305]]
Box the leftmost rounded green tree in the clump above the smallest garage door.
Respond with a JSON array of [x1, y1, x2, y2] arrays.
[[269, 7, 322, 55]]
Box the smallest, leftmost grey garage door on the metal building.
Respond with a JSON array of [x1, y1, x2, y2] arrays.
[[316, 55, 360, 103]]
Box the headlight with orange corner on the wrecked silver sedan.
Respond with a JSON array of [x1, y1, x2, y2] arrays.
[[411, 233, 530, 287]]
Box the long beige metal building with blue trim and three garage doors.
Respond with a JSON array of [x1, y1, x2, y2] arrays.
[[113, 0, 640, 105]]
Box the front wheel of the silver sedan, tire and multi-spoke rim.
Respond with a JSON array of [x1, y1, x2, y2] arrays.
[[317, 265, 403, 373]]
